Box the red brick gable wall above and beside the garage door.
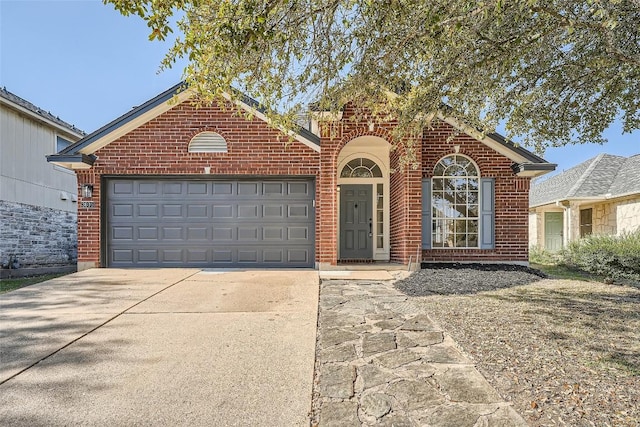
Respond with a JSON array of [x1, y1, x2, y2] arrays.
[[78, 103, 322, 266]]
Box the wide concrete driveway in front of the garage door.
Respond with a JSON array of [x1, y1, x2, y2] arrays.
[[0, 269, 319, 426]]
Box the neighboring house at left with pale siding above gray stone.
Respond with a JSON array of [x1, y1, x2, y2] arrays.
[[0, 88, 84, 277]]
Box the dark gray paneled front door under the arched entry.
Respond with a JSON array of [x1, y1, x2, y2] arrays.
[[340, 185, 373, 259]]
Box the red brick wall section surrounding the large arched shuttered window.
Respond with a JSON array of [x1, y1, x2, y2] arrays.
[[422, 123, 530, 262]]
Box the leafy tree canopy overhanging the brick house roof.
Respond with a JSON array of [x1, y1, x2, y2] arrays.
[[104, 0, 640, 152]]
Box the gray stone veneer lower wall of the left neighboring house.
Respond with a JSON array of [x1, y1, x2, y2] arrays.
[[0, 201, 78, 268]]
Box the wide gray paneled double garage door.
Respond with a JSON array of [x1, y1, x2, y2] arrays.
[[106, 179, 315, 267]]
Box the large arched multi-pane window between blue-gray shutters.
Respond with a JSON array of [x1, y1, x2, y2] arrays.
[[431, 154, 480, 248]]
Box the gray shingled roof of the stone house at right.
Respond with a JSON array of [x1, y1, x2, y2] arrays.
[[529, 154, 640, 207]]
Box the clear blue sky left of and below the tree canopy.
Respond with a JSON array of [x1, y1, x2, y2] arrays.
[[0, 0, 640, 177]]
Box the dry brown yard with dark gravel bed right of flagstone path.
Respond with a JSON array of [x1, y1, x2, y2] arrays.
[[396, 265, 640, 426]]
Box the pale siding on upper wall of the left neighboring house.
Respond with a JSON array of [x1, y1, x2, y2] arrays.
[[0, 105, 77, 212]]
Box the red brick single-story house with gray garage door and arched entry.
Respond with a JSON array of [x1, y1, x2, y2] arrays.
[[48, 84, 555, 269]]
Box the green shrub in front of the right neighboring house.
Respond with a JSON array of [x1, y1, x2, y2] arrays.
[[563, 230, 640, 280]]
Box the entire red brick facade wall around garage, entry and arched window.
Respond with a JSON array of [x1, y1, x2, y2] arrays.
[[78, 103, 529, 266]]
